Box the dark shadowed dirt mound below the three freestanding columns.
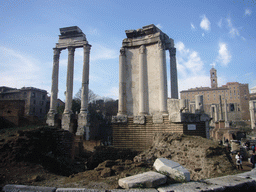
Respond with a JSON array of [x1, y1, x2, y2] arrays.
[[0, 127, 84, 176]]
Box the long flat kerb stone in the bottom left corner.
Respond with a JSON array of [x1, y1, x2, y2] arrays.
[[3, 184, 56, 192]]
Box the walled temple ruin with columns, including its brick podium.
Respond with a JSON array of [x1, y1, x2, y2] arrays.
[[112, 24, 210, 150]]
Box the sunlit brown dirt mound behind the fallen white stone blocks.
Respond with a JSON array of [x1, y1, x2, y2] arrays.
[[134, 133, 235, 180]]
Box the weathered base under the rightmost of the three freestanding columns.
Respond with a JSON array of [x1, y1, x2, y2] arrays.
[[76, 111, 90, 140]]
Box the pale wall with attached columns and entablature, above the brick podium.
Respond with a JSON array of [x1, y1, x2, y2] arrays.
[[118, 25, 178, 116]]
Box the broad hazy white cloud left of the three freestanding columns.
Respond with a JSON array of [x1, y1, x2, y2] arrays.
[[0, 46, 52, 91]]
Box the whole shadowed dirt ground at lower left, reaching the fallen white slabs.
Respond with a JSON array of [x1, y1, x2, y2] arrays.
[[0, 127, 148, 191]]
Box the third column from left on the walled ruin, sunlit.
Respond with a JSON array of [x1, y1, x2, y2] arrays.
[[158, 42, 168, 114]]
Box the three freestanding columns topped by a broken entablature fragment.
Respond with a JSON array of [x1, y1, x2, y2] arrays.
[[46, 26, 91, 135]]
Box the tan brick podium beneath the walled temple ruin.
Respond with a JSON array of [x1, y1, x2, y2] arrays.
[[112, 116, 206, 151]]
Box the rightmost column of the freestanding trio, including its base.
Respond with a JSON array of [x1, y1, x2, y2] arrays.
[[76, 44, 91, 137]]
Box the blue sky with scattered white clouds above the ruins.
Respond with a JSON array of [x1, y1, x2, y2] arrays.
[[0, 0, 256, 100]]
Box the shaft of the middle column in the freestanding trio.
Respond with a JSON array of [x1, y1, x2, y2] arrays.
[[64, 47, 75, 113]]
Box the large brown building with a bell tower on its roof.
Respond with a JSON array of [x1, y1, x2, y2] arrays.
[[180, 68, 250, 122]]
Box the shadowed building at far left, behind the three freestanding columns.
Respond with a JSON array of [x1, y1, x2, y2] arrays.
[[0, 86, 49, 123]]
